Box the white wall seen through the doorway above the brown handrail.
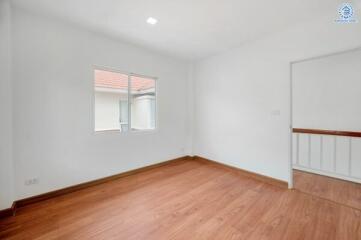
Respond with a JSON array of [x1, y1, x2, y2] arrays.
[[292, 49, 361, 131]]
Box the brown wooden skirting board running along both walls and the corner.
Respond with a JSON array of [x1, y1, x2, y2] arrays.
[[0, 156, 288, 218]]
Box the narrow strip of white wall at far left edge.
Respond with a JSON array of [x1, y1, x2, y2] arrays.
[[0, 0, 13, 210]]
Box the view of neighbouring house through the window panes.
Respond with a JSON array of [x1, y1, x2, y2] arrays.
[[94, 69, 156, 132]]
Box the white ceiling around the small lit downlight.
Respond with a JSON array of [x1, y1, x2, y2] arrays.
[[13, 0, 343, 59]]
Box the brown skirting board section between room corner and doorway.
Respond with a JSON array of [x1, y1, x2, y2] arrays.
[[193, 156, 288, 188]]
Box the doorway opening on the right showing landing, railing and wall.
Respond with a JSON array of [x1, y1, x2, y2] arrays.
[[290, 48, 361, 209]]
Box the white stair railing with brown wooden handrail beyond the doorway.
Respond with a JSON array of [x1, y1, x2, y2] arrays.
[[292, 129, 361, 183]]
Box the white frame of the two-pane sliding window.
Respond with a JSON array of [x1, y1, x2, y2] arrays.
[[91, 65, 159, 135]]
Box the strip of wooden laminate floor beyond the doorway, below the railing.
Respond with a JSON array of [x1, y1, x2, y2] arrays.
[[293, 170, 361, 210]]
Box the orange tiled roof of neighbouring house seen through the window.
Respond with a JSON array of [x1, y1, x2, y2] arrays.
[[94, 69, 155, 91]]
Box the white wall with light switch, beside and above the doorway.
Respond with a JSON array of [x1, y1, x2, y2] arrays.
[[194, 11, 361, 181]]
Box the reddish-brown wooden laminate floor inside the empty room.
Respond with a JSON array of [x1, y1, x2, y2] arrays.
[[0, 160, 361, 240]]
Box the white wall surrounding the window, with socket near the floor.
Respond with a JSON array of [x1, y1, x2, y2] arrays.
[[13, 9, 188, 202]]
